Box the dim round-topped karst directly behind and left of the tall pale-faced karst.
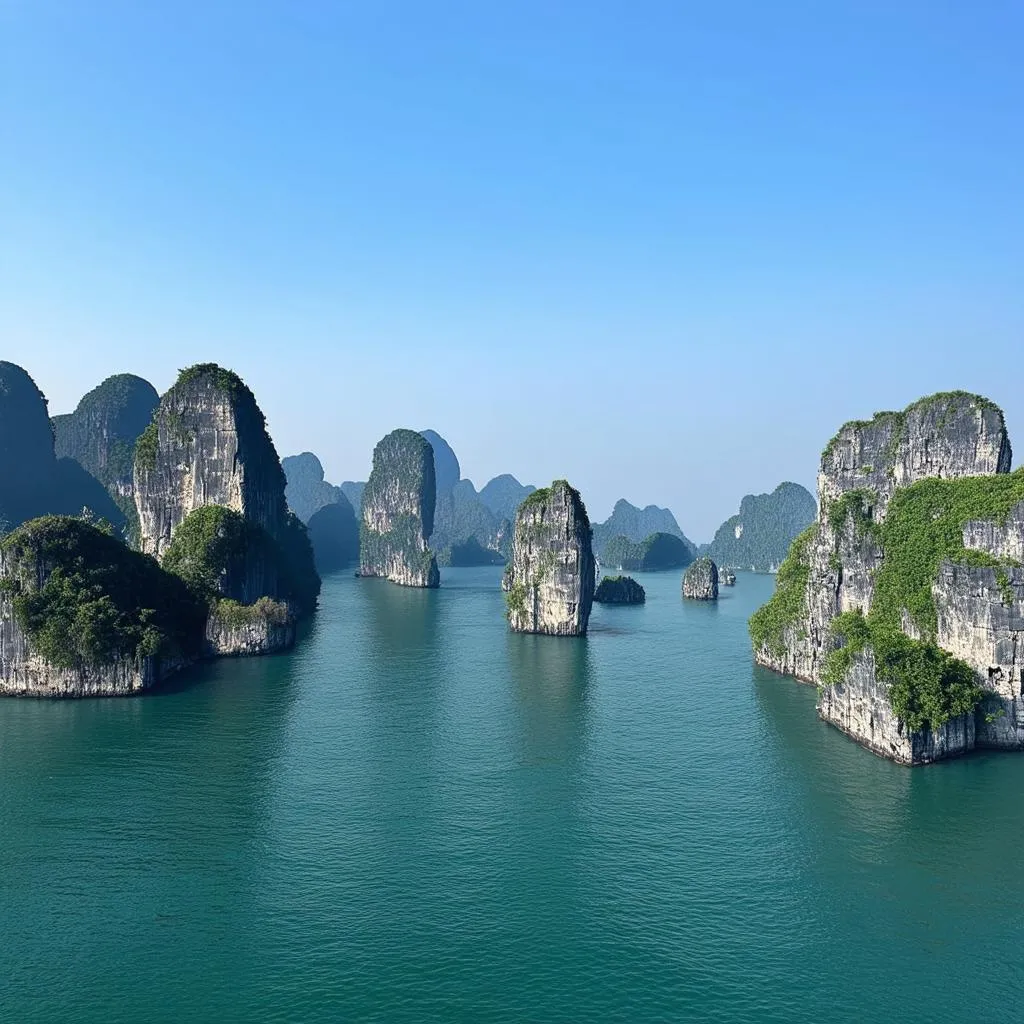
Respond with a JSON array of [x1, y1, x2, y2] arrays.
[[52, 374, 160, 521]]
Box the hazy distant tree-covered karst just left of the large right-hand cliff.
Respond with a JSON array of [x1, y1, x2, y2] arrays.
[[701, 482, 817, 572]]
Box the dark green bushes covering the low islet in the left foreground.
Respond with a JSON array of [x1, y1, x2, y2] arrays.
[[0, 516, 205, 669]]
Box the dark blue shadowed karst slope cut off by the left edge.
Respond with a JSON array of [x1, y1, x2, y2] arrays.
[[0, 361, 124, 532]]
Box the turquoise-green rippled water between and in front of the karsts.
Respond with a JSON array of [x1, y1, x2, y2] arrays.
[[0, 568, 1024, 1022]]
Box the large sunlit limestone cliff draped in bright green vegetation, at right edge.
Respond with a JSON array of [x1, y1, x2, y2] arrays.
[[751, 392, 1024, 764]]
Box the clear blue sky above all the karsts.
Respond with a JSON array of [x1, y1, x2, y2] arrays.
[[0, 0, 1024, 540]]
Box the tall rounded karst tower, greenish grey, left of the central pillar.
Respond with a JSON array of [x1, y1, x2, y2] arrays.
[[359, 429, 440, 587]]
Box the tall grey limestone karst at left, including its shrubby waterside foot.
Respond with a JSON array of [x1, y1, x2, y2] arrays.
[[134, 364, 319, 653]]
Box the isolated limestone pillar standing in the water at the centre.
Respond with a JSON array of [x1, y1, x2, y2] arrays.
[[502, 480, 596, 636]]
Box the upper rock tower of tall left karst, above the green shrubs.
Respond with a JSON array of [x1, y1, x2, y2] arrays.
[[134, 364, 287, 558]]
